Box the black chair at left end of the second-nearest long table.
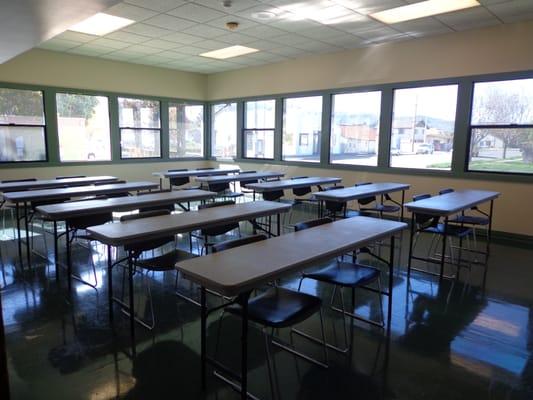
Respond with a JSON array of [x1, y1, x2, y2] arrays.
[[119, 210, 194, 330]]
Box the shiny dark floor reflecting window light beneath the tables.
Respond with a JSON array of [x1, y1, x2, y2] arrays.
[[0, 206, 533, 400]]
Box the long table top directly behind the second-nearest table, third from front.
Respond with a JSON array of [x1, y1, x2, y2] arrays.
[[37, 190, 216, 221]]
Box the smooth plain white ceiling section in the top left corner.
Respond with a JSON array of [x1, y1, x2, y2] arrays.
[[0, 0, 119, 64]]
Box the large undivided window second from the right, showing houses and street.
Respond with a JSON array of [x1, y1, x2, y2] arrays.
[[390, 85, 457, 170]]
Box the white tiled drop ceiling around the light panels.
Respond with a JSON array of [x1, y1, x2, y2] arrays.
[[33, 0, 533, 73]]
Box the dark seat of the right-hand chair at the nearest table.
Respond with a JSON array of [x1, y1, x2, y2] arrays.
[[304, 262, 380, 287]]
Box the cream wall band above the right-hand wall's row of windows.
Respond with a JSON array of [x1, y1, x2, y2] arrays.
[[208, 22, 533, 100]]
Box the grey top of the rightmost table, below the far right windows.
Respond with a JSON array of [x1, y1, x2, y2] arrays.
[[405, 190, 500, 216]]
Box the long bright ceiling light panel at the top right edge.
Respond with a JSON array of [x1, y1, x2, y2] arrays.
[[370, 0, 479, 24]]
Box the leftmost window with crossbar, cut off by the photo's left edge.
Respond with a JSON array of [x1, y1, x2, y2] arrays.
[[0, 88, 46, 162]]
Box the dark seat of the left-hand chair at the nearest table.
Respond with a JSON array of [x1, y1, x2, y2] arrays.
[[226, 287, 322, 328]]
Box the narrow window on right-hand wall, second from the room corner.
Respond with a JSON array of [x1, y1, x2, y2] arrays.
[[244, 100, 276, 159]]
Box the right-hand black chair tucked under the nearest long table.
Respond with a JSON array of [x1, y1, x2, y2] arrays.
[[294, 218, 385, 353]]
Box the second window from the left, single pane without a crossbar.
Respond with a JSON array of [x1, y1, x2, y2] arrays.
[[56, 93, 111, 161]]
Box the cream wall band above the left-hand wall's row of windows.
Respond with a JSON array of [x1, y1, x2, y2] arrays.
[[0, 49, 207, 100]]
